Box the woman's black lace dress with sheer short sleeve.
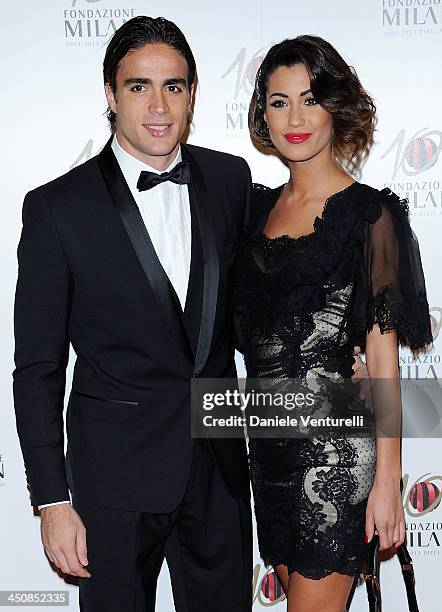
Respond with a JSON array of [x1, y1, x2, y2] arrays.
[[235, 182, 431, 578]]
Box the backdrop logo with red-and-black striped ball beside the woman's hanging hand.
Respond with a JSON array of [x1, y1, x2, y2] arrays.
[[402, 472, 442, 556]]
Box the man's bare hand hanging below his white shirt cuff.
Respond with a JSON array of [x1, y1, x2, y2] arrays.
[[40, 504, 91, 578]]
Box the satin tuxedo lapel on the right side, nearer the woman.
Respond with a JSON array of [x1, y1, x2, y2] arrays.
[[182, 145, 219, 376]]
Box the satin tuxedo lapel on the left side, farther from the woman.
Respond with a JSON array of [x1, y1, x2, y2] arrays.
[[98, 140, 194, 363]]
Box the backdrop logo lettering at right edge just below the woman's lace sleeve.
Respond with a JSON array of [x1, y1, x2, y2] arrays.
[[399, 306, 442, 380]]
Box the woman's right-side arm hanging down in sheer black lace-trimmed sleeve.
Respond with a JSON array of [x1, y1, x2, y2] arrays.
[[359, 189, 431, 549]]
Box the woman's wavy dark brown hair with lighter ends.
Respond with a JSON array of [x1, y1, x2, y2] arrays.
[[249, 35, 376, 172]]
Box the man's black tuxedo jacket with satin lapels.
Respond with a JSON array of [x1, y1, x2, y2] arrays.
[[13, 141, 251, 512]]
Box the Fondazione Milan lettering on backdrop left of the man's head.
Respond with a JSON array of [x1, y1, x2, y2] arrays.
[[63, 0, 136, 48]]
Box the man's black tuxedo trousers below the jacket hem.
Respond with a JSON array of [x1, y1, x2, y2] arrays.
[[73, 440, 252, 612]]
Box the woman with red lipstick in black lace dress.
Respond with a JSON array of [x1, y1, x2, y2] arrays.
[[236, 36, 431, 612]]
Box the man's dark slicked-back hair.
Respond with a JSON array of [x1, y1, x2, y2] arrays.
[[103, 15, 196, 128]]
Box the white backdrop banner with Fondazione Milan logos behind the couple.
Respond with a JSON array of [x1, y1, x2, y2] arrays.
[[0, 0, 442, 612]]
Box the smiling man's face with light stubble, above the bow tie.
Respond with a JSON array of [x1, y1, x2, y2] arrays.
[[105, 44, 193, 170]]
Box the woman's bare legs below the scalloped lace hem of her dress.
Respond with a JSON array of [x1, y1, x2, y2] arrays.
[[287, 572, 354, 612]]
